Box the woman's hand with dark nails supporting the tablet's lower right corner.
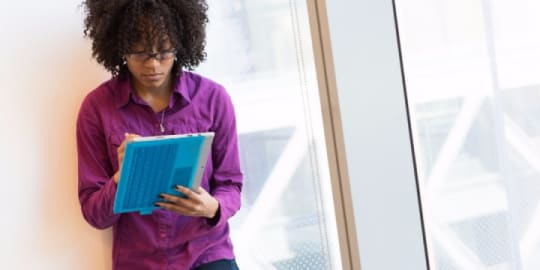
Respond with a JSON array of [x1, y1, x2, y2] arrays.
[[156, 186, 219, 218]]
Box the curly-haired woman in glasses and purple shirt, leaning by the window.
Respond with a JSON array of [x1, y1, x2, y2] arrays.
[[77, 0, 242, 270]]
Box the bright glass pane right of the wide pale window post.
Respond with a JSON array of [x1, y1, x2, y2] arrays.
[[396, 0, 540, 270]]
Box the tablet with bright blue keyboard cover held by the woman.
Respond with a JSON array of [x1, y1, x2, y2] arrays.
[[113, 132, 214, 215]]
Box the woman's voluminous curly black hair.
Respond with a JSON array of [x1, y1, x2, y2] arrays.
[[82, 0, 208, 77]]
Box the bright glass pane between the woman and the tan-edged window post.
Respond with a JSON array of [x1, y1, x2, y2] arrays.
[[197, 0, 341, 269]]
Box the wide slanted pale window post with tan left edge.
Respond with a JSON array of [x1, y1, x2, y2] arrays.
[[308, 0, 429, 270]]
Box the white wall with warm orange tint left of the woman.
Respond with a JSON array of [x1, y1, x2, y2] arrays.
[[0, 0, 111, 269]]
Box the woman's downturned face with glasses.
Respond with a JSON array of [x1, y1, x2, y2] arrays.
[[125, 42, 176, 90]]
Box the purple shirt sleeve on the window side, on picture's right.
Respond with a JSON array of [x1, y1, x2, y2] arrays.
[[208, 87, 243, 226]]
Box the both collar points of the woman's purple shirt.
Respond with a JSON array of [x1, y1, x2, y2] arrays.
[[115, 72, 191, 109]]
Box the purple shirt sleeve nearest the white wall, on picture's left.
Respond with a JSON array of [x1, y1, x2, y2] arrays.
[[76, 98, 119, 229]]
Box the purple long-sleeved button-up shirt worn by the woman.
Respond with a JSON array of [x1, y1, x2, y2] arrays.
[[77, 71, 242, 270]]
